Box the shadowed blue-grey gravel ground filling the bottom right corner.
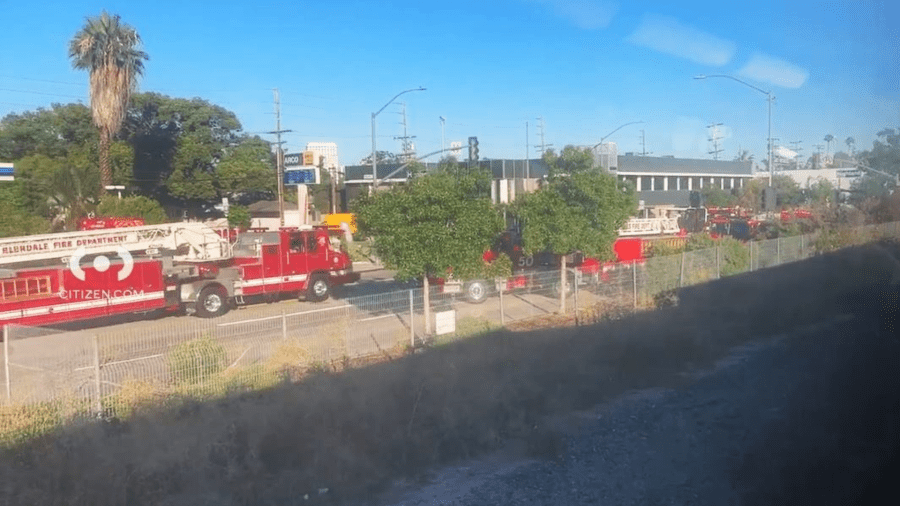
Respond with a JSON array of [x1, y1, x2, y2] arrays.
[[373, 315, 900, 506]]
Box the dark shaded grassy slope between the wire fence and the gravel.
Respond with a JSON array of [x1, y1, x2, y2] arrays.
[[0, 239, 898, 505]]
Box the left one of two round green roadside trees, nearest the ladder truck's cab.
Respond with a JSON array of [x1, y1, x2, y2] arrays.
[[353, 172, 504, 334]]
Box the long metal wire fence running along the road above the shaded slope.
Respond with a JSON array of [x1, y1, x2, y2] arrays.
[[0, 223, 900, 440]]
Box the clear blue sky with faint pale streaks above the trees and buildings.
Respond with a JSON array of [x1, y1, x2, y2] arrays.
[[0, 0, 900, 170]]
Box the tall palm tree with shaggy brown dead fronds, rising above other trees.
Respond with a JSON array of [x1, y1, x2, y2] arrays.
[[69, 11, 148, 194]]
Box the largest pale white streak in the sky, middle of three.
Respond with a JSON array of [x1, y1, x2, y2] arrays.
[[626, 15, 735, 66]]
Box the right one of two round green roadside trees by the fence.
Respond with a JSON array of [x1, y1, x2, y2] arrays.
[[513, 146, 637, 312]]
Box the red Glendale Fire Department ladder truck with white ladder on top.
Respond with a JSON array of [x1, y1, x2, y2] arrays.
[[0, 223, 359, 325]]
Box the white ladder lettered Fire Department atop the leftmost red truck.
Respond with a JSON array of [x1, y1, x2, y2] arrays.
[[0, 223, 231, 265]]
